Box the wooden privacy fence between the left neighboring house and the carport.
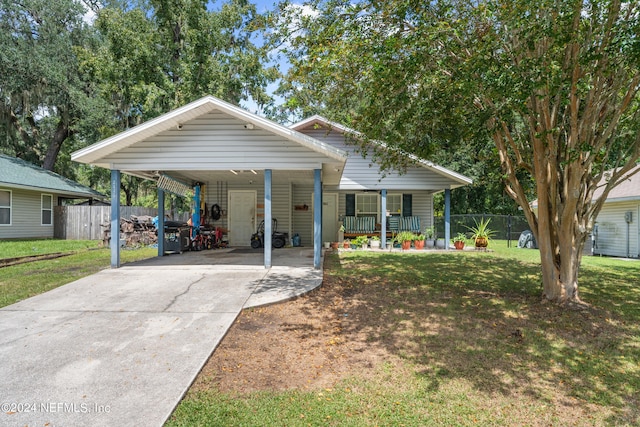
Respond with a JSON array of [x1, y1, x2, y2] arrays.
[[53, 206, 158, 240]]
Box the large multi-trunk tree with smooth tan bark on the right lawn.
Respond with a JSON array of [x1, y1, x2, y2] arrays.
[[279, 0, 640, 302]]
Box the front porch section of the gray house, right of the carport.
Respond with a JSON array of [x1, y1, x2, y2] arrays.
[[291, 116, 471, 246]]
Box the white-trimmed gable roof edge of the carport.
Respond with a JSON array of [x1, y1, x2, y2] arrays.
[[71, 96, 347, 168]]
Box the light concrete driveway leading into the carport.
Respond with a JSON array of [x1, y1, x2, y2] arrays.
[[0, 248, 322, 426]]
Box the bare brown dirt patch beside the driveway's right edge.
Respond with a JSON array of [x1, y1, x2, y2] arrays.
[[192, 258, 394, 393]]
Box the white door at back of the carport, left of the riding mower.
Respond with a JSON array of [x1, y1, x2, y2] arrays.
[[228, 190, 258, 246]]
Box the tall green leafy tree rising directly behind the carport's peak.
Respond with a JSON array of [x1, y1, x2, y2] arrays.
[[73, 0, 277, 204]]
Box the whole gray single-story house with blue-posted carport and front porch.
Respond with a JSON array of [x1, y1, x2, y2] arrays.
[[72, 96, 471, 268]]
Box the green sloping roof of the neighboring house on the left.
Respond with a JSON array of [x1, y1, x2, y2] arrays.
[[0, 154, 105, 198]]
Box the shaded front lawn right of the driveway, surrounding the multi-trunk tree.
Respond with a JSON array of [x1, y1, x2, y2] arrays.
[[167, 242, 640, 426]]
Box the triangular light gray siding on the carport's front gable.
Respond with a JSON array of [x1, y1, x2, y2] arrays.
[[101, 112, 327, 170]]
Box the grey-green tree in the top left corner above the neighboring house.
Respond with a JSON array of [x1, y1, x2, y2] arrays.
[[0, 0, 107, 172]]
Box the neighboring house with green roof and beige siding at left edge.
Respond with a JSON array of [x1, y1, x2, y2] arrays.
[[0, 154, 104, 239]]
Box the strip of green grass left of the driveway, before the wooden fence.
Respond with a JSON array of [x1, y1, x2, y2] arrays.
[[0, 240, 158, 307]]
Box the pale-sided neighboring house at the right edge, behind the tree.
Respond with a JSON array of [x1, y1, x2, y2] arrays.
[[593, 164, 640, 258]]
